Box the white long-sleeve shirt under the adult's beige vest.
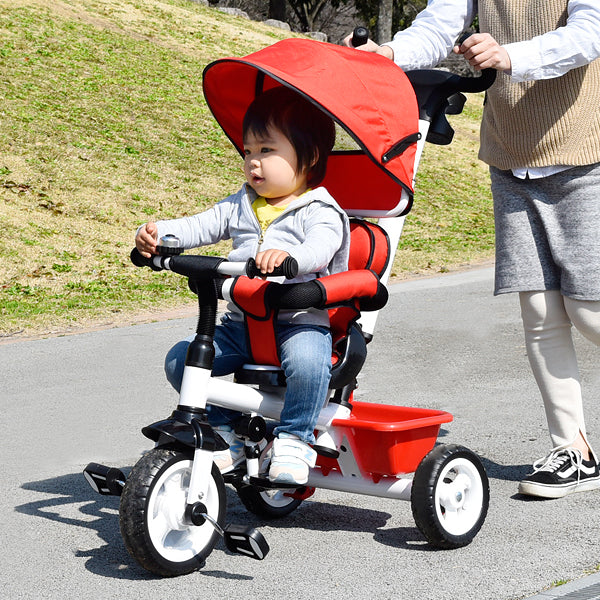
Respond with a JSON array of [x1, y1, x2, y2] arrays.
[[384, 0, 600, 178]]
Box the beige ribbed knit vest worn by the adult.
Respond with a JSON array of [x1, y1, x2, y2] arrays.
[[479, 0, 600, 170]]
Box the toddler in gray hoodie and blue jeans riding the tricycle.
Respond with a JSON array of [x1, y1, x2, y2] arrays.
[[136, 87, 350, 485]]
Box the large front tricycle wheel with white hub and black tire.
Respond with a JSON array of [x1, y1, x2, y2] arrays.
[[119, 448, 226, 577]]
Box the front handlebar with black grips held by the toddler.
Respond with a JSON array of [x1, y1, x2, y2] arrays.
[[130, 248, 298, 279]]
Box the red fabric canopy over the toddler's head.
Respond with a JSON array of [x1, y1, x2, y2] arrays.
[[203, 38, 419, 216]]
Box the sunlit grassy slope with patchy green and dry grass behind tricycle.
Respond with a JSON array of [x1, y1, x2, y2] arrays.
[[0, 0, 493, 339]]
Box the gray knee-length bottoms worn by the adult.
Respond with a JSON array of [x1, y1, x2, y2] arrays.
[[490, 163, 600, 300]]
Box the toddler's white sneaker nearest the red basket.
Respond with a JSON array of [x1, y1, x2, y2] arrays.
[[269, 433, 317, 485]]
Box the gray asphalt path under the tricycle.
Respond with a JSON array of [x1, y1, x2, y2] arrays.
[[0, 269, 600, 600]]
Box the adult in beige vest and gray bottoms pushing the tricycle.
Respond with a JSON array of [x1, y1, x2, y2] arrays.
[[345, 0, 600, 498]]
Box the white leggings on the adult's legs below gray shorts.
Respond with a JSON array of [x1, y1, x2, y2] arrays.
[[519, 290, 600, 448]]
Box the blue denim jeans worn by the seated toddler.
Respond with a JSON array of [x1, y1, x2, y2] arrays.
[[165, 315, 331, 444]]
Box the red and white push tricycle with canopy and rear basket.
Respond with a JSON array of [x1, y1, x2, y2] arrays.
[[84, 32, 494, 577]]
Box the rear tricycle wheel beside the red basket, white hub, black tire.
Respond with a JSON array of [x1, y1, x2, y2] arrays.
[[411, 444, 490, 549]]
